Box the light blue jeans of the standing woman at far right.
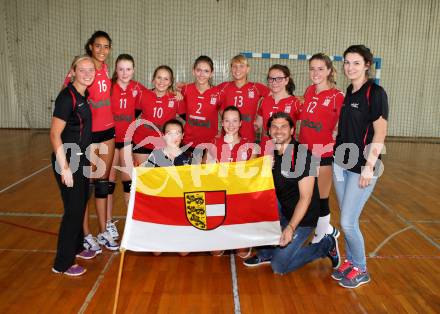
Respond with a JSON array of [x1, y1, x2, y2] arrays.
[[333, 163, 377, 270]]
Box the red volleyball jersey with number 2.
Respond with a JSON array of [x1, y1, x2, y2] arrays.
[[182, 83, 220, 147]]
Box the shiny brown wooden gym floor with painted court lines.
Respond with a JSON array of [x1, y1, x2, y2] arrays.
[[0, 130, 440, 314]]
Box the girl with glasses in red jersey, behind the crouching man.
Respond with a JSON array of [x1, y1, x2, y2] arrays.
[[256, 64, 301, 145]]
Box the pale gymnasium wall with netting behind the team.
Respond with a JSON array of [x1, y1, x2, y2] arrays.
[[0, 0, 440, 137]]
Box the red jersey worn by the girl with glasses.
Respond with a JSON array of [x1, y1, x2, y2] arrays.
[[258, 95, 301, 141]]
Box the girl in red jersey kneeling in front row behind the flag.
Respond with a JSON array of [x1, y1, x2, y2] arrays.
[[206, 106, 255, 258]]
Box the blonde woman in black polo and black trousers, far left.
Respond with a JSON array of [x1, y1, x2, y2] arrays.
[[50, 56, 96, 276]]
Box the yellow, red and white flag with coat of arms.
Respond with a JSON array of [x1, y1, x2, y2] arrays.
[[121, 157, 281, 252]]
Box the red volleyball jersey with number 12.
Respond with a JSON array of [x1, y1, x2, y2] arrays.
[[299, 85, 344, 157]]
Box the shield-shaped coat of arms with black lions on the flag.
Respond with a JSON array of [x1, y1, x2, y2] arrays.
[[183, 190, 226, 231]]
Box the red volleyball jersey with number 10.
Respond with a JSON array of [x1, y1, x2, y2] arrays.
[[133, 91, 182, 149]]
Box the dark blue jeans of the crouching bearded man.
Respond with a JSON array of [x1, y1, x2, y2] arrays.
[[257, 214, 332, 274]]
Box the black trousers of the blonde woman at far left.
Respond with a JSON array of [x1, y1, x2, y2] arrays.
[[52, 154, 89, 272]]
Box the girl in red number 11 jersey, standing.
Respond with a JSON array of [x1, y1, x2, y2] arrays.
[[106, 54, 145, 240]]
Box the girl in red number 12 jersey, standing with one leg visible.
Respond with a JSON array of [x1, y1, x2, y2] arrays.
[[299, 53, 344, 243]]
